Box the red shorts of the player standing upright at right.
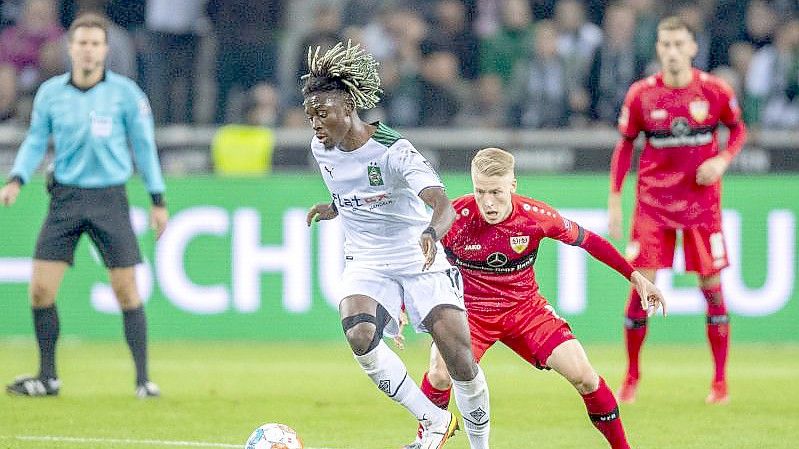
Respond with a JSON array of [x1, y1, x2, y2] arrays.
[[626, 220, 730, 276]]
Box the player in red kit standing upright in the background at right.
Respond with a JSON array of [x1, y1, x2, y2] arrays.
[[608, 17, 746, 403]]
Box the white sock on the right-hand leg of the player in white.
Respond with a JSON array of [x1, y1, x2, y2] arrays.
[[452, 365, 491, 449]]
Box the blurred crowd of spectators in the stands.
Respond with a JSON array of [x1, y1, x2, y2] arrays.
[[0, 0, 799, 129]]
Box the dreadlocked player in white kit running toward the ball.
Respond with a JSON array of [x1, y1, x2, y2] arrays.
[[302, 43, 489, 449]]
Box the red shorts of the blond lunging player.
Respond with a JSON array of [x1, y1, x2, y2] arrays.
[[467, 301, 574, 369]]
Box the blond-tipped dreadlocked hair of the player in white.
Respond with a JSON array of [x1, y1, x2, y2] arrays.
[[300, 41, 383, 109]]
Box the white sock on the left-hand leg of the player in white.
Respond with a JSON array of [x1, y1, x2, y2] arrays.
[[355, 340, 450, 426]]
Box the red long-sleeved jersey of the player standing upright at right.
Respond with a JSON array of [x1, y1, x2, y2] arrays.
[[611, 69, 746, 229]]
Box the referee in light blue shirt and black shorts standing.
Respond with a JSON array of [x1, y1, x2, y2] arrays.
[[0, 14, 169, 398]]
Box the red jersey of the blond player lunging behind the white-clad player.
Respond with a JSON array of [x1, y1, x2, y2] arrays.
[[441, 194, 585, 312]]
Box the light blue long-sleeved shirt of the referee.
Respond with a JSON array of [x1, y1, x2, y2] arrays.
[[11, 70, 164, 194]]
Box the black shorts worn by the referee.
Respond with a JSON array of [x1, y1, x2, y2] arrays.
[[35, 184, 141, 268]]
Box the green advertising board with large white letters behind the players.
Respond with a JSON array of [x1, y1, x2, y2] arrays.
[[0, 174, 799, 342]]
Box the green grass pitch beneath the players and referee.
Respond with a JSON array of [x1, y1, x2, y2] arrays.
[[0, 339, 799, 449]]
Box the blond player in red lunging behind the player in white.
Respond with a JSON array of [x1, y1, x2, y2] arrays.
[[405, 148, 666, 449]]
